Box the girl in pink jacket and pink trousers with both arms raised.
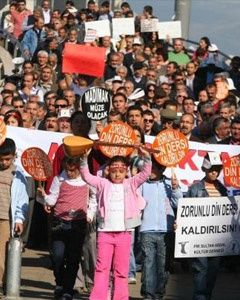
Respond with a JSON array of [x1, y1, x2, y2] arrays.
[[81, 148, 151, 300]]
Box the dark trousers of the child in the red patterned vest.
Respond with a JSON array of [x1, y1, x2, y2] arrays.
[[51, 219, 86, 295]]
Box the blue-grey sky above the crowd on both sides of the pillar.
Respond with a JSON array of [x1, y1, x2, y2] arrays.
[[127, 0, 240, 56]]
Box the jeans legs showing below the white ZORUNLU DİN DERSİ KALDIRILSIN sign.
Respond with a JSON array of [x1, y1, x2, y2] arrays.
[[192, 257, 220, 300]]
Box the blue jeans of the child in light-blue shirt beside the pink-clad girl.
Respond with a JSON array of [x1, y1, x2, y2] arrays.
[[141, 232, 170, 299]]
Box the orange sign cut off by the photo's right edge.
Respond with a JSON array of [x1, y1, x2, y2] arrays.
[[223, 155, 240, 188]]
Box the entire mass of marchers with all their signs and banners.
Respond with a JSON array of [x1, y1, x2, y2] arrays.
[[0, 0, 240, 300]]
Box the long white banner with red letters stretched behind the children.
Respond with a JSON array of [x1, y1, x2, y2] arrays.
[[4, 126, 240, 195]]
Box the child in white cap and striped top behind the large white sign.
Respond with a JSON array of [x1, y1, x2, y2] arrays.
[[186, 152, 227, 300]]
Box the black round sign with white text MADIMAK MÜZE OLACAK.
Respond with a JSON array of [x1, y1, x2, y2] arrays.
[[81, 87, 111, 121]]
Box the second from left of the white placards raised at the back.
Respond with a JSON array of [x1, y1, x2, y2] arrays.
[[112, 18, 135, 37]]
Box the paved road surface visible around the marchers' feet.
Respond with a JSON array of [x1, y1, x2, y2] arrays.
[[2, 249, 240, 300]]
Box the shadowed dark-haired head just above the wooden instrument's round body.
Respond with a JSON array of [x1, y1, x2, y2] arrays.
[[70, 111, 91, 137]]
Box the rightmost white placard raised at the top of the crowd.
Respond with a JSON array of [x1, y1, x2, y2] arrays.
[[158, 21, 182, 39]]
